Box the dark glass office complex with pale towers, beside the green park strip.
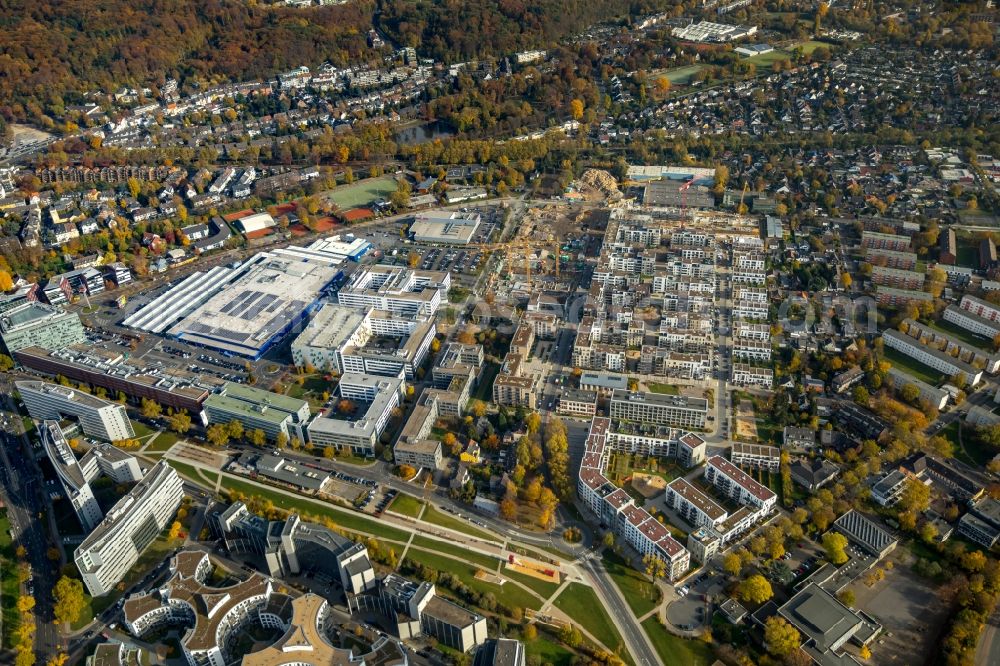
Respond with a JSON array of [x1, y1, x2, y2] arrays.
[[215, 502, 375, 594]]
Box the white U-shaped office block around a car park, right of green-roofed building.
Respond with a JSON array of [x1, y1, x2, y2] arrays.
[[306, 372, 404, 457]]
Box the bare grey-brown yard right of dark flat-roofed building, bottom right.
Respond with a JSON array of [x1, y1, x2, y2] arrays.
[[851, 562, 948, 666]]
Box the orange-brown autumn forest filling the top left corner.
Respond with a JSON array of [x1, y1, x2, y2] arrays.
[[0, 0, 374, 120]]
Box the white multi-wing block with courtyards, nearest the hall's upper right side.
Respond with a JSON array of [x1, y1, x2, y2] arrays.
[[337, 264, 451, 317]]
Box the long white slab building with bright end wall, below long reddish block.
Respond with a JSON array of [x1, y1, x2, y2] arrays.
[[14, 381, 135, 442]]
